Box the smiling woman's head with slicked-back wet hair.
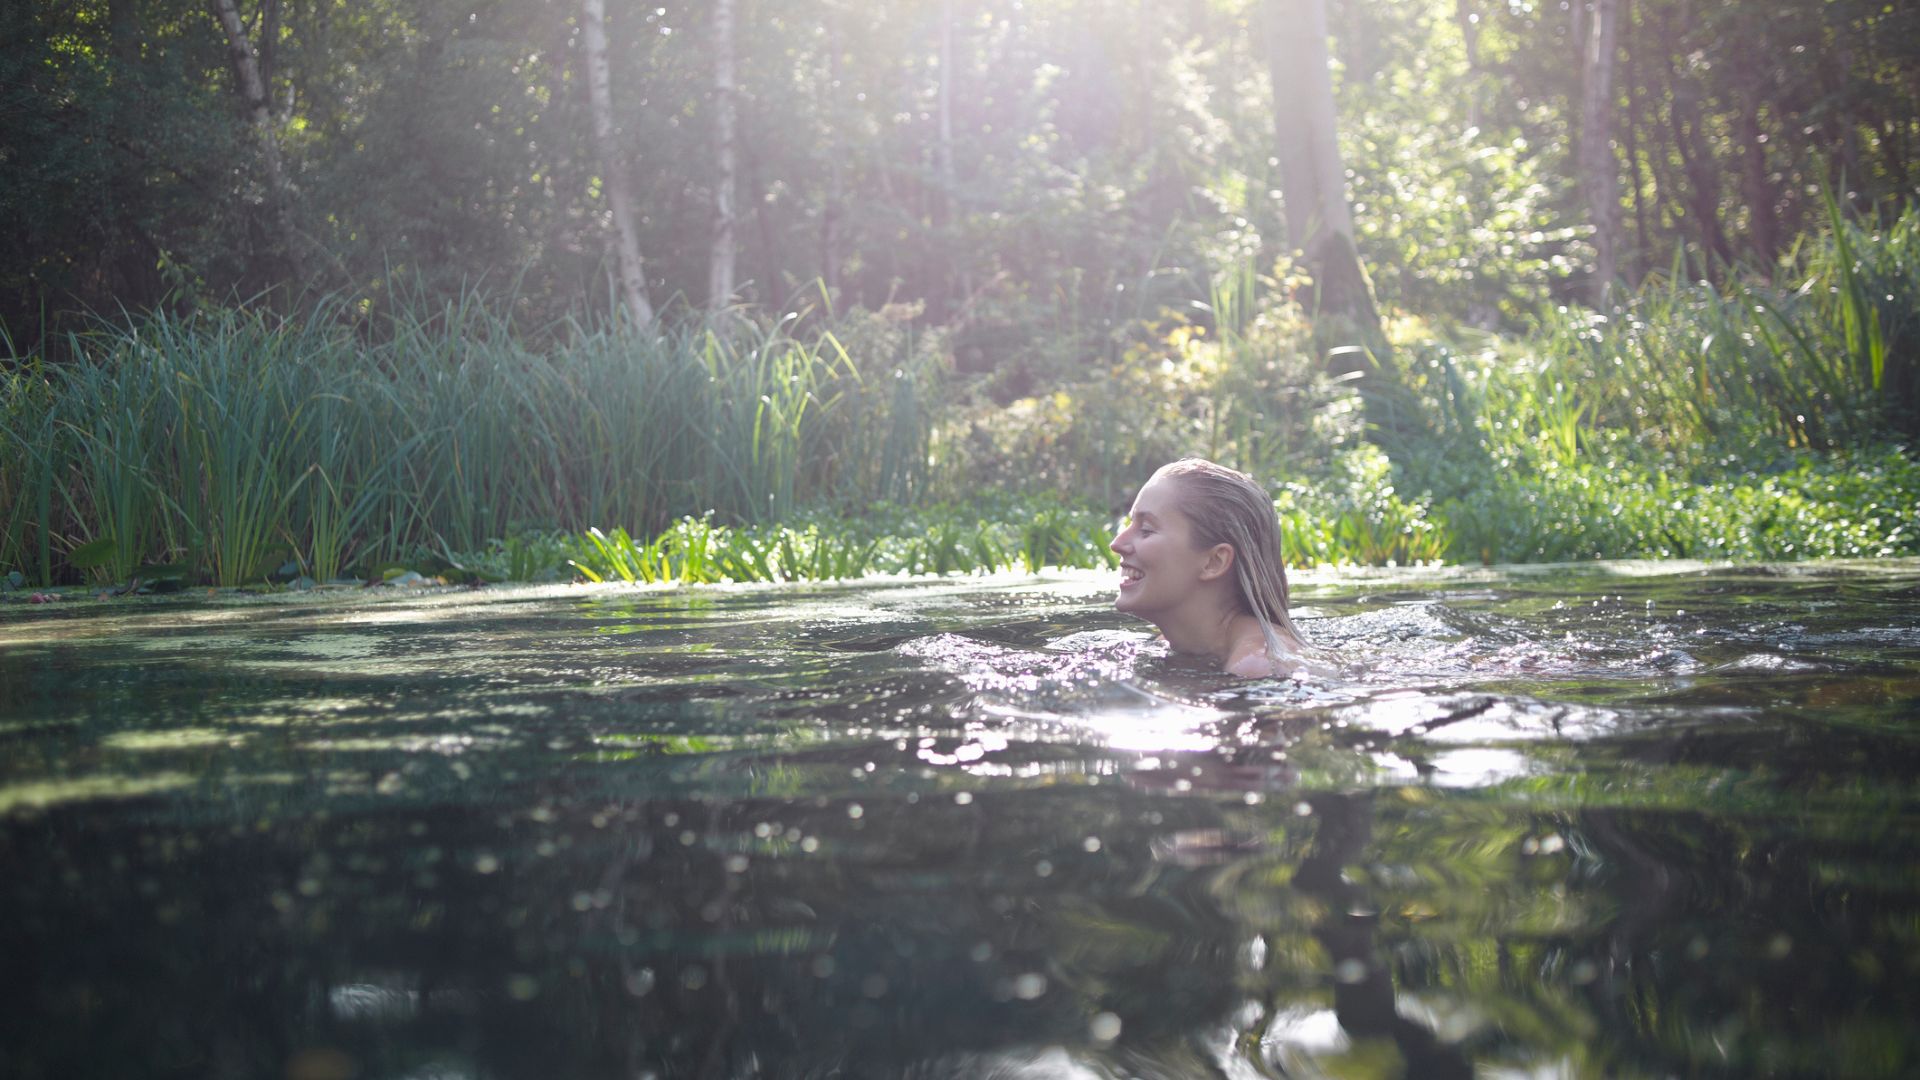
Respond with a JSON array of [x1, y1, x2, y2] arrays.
[[1112, 457, 1304, 651]]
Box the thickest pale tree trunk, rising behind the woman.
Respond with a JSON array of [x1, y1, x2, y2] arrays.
[[1267, 0, 1384, 361]]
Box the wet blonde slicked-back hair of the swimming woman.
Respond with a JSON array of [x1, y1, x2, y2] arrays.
[[1154, 457, 1309, 655]]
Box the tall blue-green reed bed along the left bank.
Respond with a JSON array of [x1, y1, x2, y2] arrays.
[[0, 296, 939, 586]]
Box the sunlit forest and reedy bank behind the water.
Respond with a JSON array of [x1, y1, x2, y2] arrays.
[[0, 0, 1920, 588]]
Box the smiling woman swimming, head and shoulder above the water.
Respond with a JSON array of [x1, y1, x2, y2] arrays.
[[1110, 457, 1309, 678]]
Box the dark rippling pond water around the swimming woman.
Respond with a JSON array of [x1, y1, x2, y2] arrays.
[[0, 561, 1920, 1080]]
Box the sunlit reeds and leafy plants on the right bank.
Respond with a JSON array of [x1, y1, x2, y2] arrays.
[[1388, 199, 1920, 561]]
